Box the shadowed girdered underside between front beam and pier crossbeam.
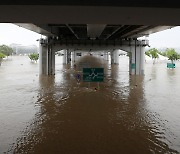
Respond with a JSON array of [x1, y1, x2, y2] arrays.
[[16, 23, 173, 42]]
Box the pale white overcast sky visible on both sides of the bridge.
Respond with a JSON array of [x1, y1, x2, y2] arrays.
[[0, 23, 180, 48]]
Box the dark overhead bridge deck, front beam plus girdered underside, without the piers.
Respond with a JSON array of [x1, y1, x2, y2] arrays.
[[0, 3, 177, 40]]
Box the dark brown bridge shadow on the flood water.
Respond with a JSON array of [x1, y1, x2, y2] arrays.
[[12, 56, 177, 154]]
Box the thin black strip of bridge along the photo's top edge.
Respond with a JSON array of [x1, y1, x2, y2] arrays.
[[0, 0, 180, 8]]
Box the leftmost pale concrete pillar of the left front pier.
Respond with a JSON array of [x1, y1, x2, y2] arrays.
[[39, 40, 48, 75]]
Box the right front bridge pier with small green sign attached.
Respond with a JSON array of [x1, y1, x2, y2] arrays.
[[129, 46, 145, 75]]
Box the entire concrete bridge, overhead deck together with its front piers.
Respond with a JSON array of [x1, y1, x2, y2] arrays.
[[0, 0, 180, 74]]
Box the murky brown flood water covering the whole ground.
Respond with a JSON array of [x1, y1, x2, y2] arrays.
[[0, 56, 180, 154]]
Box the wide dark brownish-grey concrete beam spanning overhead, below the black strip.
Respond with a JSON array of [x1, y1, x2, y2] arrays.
[[0, 5, 180, 26]]
